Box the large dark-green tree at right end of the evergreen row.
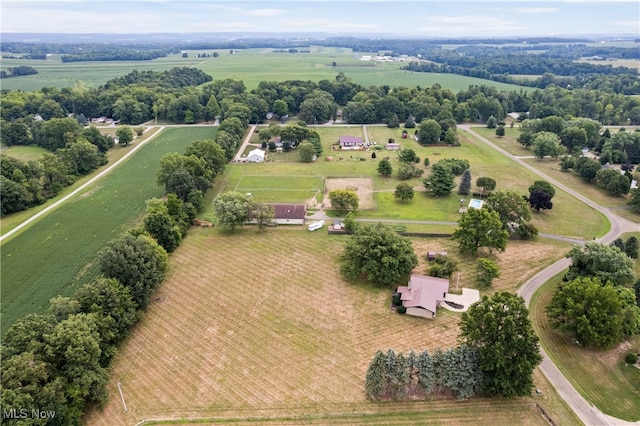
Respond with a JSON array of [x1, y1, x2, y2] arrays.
[[459, 292, 542, 398]]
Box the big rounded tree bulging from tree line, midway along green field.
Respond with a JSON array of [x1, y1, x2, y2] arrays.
[[98, 234, 168, 310]]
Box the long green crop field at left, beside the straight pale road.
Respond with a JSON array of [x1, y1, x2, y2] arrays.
[[1, 127, 215, 333]]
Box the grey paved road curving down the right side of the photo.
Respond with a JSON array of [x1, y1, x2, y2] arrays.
[[460, 126, 640, 426]]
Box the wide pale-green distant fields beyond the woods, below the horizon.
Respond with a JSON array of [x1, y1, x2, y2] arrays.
[[2, 46, 531, 92]]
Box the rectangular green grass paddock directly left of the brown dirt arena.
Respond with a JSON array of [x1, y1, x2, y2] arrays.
[[235, 175, 324, 203]]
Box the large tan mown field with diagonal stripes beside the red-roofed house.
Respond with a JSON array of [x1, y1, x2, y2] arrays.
[[84, 230, 575, 426]]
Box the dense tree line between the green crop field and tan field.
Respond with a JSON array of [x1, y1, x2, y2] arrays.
[[0, 129, 235, 425]]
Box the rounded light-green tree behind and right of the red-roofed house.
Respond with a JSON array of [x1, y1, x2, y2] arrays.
[[451, 208, 509, 255]]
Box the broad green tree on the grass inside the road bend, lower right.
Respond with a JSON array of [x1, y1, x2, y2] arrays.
[[546, 277, 640, 349]]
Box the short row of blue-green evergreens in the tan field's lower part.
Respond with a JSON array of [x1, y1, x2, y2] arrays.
[[364, 345, 482, 400]]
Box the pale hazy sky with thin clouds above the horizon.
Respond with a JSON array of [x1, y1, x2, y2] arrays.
[[0, 0, 640, 37]]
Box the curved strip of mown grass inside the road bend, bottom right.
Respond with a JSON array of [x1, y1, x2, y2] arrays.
[[531, 274, 640, 422]]
